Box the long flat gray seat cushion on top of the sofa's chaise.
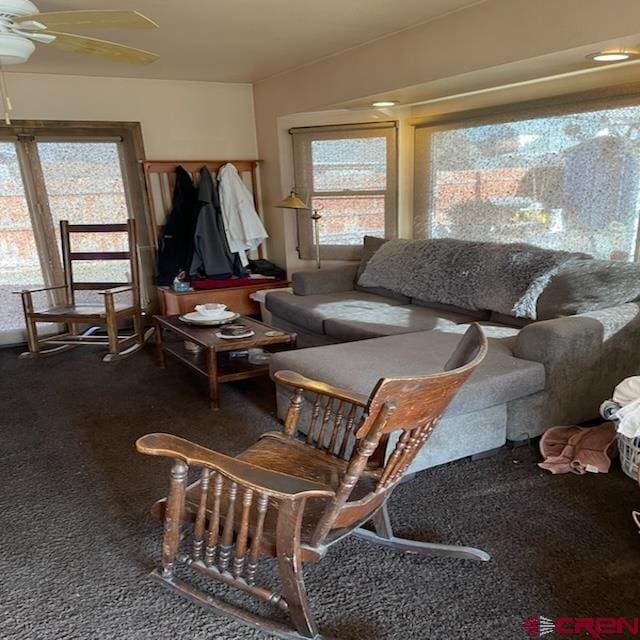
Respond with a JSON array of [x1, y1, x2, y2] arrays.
[[271, 327, 545, 416]]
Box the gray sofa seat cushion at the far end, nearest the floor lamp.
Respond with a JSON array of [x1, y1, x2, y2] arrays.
[[267, 291, 400, 333]]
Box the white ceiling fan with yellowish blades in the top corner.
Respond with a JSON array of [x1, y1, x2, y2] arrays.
[[0, 0, 158, 65]]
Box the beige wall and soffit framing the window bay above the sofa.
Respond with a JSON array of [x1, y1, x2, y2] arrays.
[[254, 0, 640, 267]]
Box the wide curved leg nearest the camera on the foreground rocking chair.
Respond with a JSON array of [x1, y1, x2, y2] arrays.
[[277, 502, 320, 638]]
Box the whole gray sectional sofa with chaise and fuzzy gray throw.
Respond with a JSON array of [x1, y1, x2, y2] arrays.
[[266, 238, 640, 471]]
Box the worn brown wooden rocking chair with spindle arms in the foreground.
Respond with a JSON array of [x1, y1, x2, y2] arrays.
[[137, 324, 489, 639]]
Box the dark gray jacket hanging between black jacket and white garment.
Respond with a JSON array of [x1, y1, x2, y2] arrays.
[[189, 167, 245, 278]]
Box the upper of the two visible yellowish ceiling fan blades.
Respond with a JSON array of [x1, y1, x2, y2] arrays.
[[14, 10, 158, 31]]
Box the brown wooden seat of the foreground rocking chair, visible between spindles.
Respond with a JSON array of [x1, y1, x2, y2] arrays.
[[180, 431, 378, 562]]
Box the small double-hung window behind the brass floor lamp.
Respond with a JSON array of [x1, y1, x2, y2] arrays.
[[291, 122, 397, 259]]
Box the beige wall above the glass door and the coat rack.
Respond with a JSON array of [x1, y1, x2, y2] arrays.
[[7, 73, 257, 160]]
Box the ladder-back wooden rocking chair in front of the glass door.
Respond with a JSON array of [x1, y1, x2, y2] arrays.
[[17, 220, 144, 362]]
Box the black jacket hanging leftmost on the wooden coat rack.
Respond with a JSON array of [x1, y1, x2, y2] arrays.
[[158, 167, 198, 285]]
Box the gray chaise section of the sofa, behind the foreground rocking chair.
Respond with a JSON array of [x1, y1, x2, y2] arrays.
[[271, 326, 545, 471]]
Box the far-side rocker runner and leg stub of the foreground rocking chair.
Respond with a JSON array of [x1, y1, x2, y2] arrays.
[[353, 504, 491, 562]]
